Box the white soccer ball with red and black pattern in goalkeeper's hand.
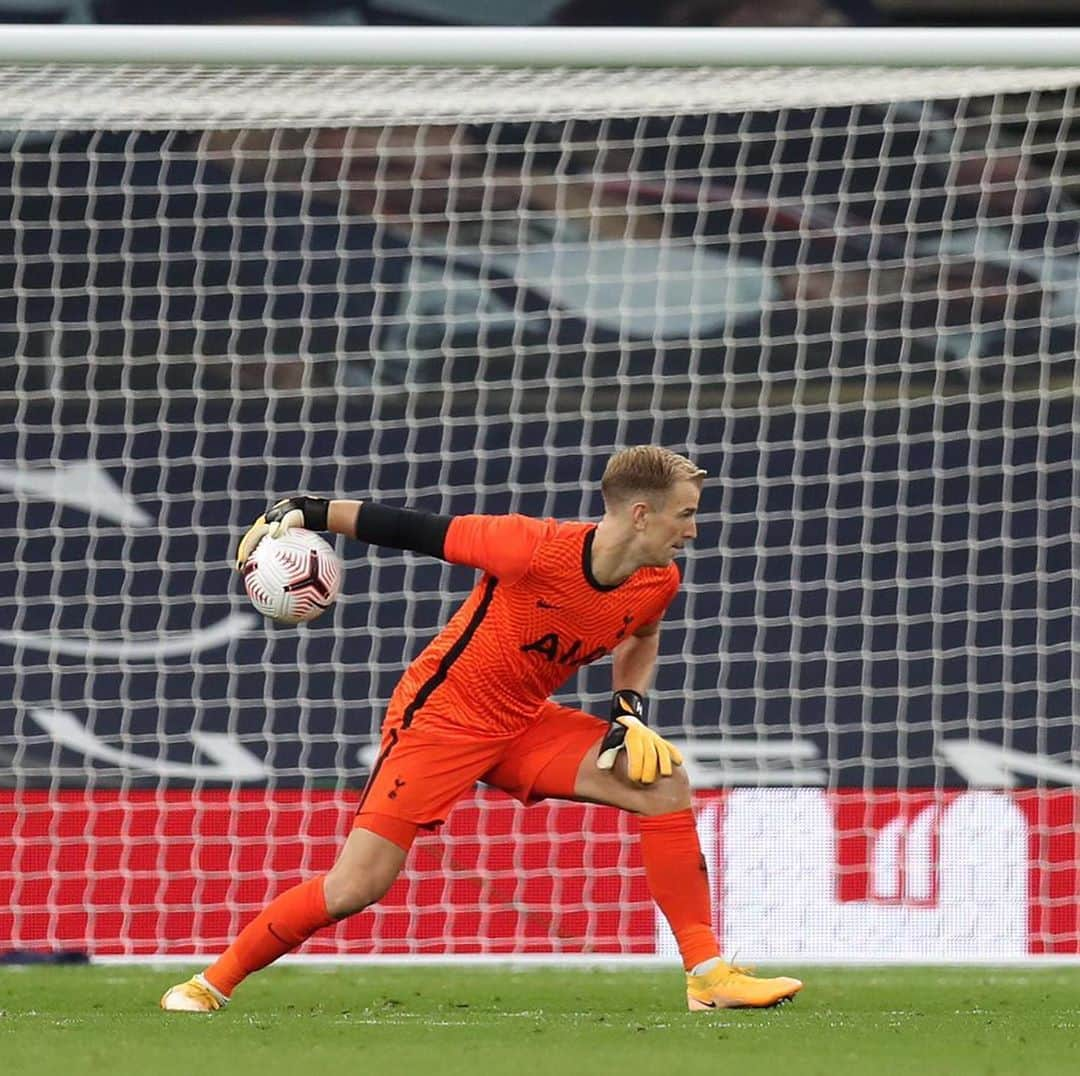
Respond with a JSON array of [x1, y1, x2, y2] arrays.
[[243, 527, 345, 624]]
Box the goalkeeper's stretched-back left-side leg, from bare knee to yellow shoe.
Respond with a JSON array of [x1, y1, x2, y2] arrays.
[[161, 829, 407, 1012]]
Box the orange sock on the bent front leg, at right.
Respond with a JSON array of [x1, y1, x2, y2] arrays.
[[638, 809, 720, 971]]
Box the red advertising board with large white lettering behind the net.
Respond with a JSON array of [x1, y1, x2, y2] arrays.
[[0, 790, 1080, 959]]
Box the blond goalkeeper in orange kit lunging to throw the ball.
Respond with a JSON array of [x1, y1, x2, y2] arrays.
[[161, 446, 802, 1012]]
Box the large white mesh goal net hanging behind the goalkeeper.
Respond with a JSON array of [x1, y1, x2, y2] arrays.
[[0, 29, 1080, 960]]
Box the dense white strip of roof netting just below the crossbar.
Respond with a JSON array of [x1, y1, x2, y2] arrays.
[[6, 64, 1080, 130]]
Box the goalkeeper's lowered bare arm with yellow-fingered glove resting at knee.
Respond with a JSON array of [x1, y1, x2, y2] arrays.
[[596, 624, 683, 784]]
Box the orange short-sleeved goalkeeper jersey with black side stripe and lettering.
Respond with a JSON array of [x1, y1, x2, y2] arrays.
[[388, 515, 679, 736]]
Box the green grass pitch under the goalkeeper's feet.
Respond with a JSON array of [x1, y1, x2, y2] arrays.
[[0, 966, 1080, 1076]]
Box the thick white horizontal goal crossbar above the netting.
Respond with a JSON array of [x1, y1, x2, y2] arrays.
[[0, 26, 1080, 68]]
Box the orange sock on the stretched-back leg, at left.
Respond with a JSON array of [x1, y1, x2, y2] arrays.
[[203, 875, 335, 997]]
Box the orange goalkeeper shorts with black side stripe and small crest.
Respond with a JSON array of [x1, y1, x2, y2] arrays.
[[353, 702, 609, 848]]
